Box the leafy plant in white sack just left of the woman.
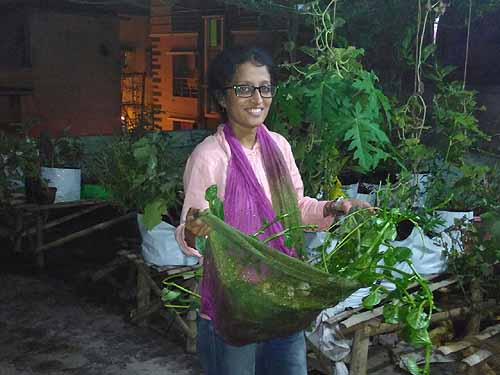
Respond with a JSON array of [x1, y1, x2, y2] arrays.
[[93, 130, 197, 265]]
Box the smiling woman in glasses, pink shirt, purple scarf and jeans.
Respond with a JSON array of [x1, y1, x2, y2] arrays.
[[176, 48, 369, 375]]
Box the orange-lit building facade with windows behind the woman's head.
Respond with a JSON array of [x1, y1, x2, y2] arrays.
[[150, 0, 287, 130]]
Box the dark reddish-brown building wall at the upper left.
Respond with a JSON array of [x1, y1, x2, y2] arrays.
[[0, 1, 120, 136]]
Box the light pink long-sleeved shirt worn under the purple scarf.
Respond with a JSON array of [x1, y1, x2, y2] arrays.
[[175, 125, 333, 257]]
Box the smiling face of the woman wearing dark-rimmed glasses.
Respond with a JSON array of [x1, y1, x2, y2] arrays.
[[220, 62, 272, 130]]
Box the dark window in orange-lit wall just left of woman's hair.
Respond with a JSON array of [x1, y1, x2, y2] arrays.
[[172, 52, 198, 98]]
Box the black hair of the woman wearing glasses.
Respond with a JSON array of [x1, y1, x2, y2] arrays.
[[208, 47, 274, 118]]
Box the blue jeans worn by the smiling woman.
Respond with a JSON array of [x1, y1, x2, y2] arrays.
[[198, 318, 307, 375]]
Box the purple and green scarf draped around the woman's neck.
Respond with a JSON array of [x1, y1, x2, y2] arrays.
[[201, 124, 304, 319]]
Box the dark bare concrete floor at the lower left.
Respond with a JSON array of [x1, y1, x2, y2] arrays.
[[0, 273, 200, 375]]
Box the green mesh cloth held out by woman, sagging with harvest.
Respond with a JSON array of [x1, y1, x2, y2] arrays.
[[200, 211, 360, 345]]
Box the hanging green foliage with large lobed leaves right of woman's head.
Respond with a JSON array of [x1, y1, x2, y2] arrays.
[[268, 3, 390, 196]]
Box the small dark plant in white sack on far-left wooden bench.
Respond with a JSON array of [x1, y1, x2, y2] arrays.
[[39, 129, 83, 202]]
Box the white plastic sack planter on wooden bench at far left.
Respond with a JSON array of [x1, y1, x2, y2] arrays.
[[41, 167, 81, 202]]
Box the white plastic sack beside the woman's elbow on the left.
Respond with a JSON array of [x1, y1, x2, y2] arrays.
[[137, 215, 199, 266]]
